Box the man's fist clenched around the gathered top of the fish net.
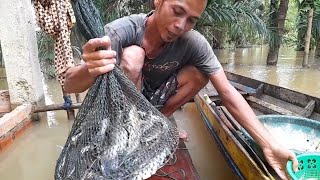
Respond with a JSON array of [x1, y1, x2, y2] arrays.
[[82, 36, 116, 79]]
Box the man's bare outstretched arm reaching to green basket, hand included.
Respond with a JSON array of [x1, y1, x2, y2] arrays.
[[209, 70, 298, 179]]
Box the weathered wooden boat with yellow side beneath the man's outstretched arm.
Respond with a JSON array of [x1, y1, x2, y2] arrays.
[[195, 72, 320, 179]]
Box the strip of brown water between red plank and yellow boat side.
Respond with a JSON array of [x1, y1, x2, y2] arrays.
[[174, 103, 237, 180]]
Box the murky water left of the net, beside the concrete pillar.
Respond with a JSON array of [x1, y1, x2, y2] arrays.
[[0, 77, 72, 180]]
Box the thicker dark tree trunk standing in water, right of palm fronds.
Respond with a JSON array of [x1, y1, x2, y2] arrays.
[[267, 0, 289, 65]]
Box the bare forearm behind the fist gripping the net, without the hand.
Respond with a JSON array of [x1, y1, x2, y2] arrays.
[[64, 64, 95, 93]]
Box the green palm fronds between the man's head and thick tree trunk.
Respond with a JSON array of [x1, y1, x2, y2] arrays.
[[196, 0, 268, 47]]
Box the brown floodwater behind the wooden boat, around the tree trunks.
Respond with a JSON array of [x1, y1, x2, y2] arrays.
[[215, 46, 320, 97]]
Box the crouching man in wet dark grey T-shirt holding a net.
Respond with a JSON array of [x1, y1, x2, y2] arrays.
[[64, 0, 298, 179]]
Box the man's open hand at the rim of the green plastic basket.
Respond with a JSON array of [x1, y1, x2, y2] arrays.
[[263, 143, 299, 179]]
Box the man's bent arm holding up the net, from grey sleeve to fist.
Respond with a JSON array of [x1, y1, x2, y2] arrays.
[[64, 16, 137, 93]]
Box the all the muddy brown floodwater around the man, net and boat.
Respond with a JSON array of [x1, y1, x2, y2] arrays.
[[0, 47, 320, 180]]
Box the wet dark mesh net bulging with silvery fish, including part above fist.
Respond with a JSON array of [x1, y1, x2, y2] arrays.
[[55, 0, 178, 180]]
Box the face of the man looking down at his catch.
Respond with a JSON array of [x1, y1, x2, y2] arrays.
[[154, 0, 206, 42]]
